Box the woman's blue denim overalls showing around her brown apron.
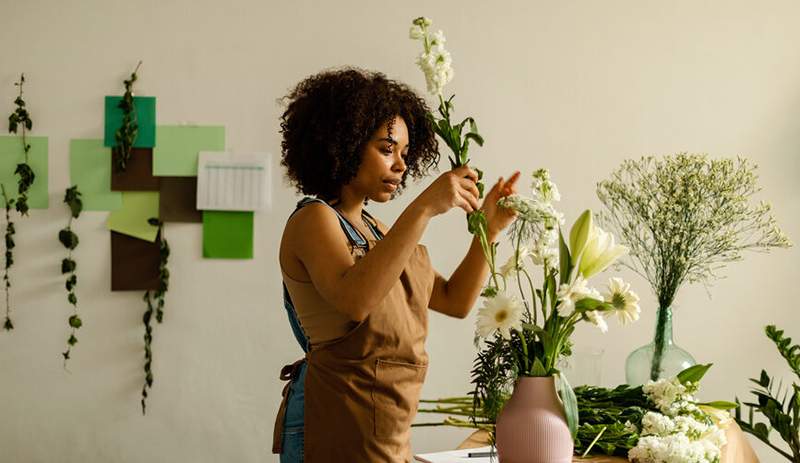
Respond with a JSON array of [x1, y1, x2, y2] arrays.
[[273, 197, 383, 463]]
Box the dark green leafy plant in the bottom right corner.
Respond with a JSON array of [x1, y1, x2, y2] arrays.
[[736, 325, 800, 463]]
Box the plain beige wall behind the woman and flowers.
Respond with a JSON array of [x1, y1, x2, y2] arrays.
[[0, 0, 800, 462]]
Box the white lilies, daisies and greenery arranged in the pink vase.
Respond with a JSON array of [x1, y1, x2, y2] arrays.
[[473, 169, 639, 436]]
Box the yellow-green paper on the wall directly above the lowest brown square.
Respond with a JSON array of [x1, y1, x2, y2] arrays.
[[106, 191, 158, 241]]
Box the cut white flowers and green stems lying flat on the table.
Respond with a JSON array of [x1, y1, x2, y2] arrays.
[[416, 364, 736, 463]]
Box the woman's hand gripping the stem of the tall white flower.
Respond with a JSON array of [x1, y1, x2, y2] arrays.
[[414, 165, 480, 217]]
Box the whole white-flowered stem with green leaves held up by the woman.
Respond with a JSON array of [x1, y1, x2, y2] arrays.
[[409, 17, 494, 252]]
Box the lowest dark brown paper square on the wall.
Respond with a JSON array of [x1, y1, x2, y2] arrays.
[[111, 231, 160, 291]]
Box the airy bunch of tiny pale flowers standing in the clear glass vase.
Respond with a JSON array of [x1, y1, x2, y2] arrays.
[[597, 153, 791, 384]]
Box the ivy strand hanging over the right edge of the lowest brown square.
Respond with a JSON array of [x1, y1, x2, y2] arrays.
[[142, 218, 169, 415]]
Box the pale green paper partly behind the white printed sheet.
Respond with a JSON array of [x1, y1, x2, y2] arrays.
[[153, 125, 225, 177]]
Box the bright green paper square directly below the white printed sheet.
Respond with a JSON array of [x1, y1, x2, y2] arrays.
[[203, 211, 253, 259]]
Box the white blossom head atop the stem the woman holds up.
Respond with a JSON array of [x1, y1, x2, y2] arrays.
[[408, 17, 453, 96]]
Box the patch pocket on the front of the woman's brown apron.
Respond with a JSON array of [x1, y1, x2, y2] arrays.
[[372, 360, 428, 437]]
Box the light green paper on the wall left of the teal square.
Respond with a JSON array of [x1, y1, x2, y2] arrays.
[[69, 140, 122, 211]]
